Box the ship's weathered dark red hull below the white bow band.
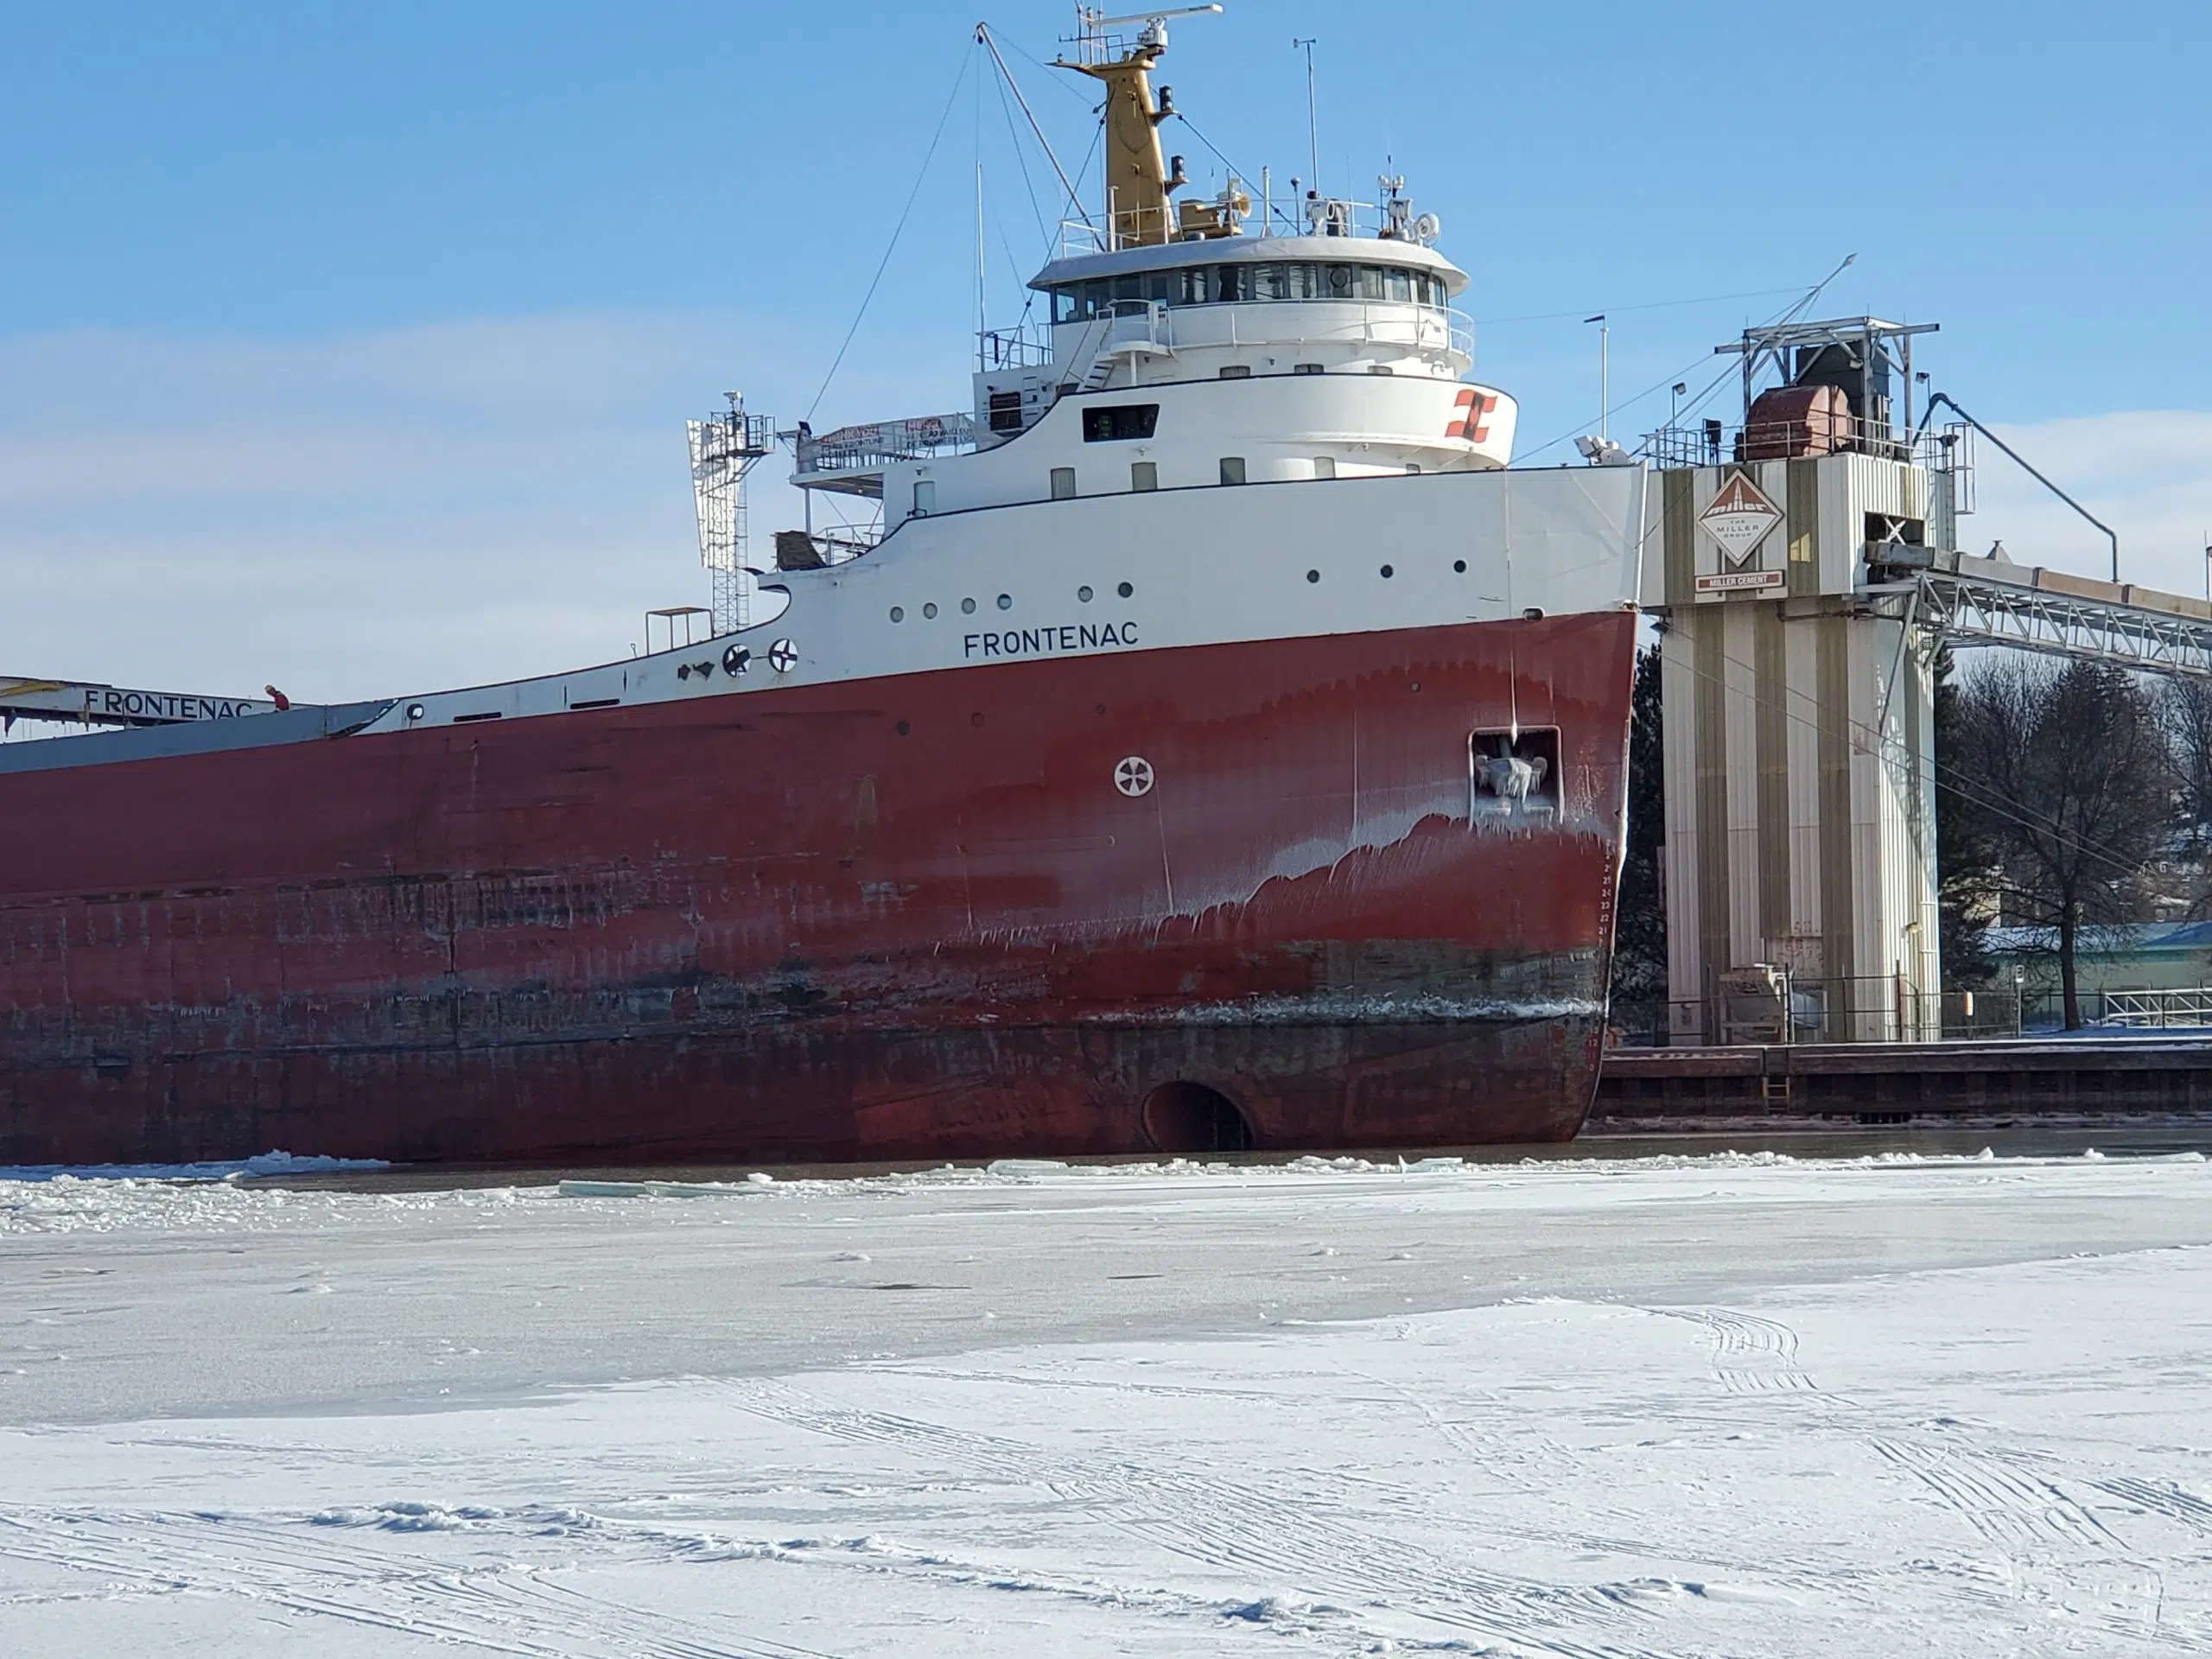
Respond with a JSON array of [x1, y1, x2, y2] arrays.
[[0, 613, 1635, 1164]]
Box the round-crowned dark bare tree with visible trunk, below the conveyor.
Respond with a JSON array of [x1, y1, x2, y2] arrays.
[[1944, 657, 2174, 1031]]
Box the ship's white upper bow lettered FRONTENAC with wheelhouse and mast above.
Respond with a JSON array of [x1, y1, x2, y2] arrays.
[[332, 10, 1643, 730]]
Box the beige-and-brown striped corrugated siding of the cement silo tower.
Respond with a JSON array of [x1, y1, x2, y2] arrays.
[[1656, 455, 1940, 1039]]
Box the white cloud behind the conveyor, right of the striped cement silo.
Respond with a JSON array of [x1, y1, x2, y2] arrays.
[[1958, 410, 2212, 595]]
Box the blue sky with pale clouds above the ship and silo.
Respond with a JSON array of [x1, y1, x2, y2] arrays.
[[0, 0, 2212, 690]]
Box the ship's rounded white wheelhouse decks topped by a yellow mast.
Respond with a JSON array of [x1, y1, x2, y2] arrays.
[[779, 16, 1516, 546]]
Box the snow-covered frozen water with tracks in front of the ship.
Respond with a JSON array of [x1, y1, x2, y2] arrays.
[[0, 1154, 2212, 1659]]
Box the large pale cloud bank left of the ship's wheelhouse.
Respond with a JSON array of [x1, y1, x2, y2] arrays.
[[0, 315, 960, 699]]
